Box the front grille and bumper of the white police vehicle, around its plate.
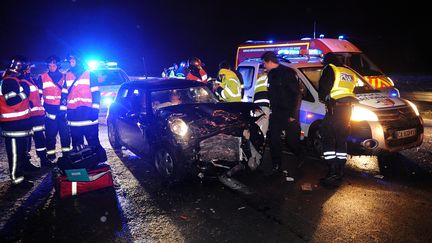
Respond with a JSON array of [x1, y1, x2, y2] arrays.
[[376, 106, 423, 147]]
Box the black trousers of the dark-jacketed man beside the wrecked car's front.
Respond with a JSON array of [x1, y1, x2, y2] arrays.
[[270, 111, 304, 168]]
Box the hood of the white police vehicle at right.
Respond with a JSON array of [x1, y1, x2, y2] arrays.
[[356, 93, 406, 109]]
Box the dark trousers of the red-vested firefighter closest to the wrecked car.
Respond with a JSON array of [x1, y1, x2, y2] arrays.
[[70, 124, 107, 162]]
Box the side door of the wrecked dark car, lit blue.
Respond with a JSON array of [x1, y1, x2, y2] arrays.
[[122, 88, 149, 154]]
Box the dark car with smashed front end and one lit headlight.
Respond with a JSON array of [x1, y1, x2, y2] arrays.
[[107, 79, 264, 181]]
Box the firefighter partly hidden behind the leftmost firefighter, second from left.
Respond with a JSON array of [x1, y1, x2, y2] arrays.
[[19, 63, 52, 167]]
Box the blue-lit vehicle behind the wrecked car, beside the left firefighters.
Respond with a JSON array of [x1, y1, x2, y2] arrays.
[[87, 60, 129, 115]]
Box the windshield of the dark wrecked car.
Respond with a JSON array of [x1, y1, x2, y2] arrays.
[[151, 86, 217, 110]]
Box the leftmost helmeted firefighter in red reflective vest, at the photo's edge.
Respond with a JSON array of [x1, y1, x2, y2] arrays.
[[0, 57, 33, 187]]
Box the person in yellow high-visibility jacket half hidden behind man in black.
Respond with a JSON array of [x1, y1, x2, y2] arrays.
[[253, 70, 270, 136]]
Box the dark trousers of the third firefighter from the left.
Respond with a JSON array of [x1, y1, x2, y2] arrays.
[[45, 114, 71, 154]]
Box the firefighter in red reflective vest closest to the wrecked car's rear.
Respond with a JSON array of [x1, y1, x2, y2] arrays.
[[65, 54, 107, 162]]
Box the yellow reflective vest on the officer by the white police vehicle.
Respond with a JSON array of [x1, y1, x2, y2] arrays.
[[329, 64, 358, 100]]
